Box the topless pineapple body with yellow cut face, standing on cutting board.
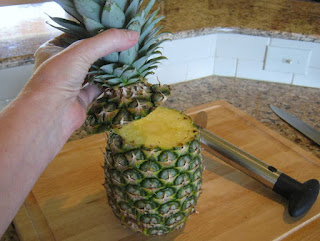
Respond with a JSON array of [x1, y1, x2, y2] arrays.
[[104, 107, 203, 235]]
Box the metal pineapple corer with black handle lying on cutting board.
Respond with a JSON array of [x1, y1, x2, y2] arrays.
[[194, 111, 319, 217]]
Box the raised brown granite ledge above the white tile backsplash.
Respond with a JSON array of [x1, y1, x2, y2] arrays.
[[0, 0, 320, 69]]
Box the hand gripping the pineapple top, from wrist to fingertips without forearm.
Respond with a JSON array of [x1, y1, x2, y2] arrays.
[[26, 29, 139, 131]]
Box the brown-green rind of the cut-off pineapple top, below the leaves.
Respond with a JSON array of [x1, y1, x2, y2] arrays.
[[86, 82, 171, 133]]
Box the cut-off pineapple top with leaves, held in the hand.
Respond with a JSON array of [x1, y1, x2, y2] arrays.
[[51, 0, 170, 132]]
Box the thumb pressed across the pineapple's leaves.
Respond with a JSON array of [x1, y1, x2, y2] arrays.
[[37, 29, 139, 86]]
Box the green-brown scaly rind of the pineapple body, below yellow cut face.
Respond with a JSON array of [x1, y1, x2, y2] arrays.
[[104, 131, 203, 236]]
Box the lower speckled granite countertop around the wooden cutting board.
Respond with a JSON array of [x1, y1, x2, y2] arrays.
[[1, 76, 320, 241]]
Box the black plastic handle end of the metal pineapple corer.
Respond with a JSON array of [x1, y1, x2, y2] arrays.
[[273, 173, 319, 217]]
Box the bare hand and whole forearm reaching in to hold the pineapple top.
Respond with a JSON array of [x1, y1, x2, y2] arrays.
[[0, 29, 139, 237]]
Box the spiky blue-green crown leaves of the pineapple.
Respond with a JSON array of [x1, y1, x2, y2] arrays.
[[49, 0, 168, 87]]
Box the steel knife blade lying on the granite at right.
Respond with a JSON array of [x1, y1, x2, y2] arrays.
[[270, 105, 320, 146]]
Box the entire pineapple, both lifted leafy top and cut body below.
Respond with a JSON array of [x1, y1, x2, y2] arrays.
[[51, 0, 202, 235]]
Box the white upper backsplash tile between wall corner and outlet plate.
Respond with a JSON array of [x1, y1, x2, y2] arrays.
[[216, 34, 270, 60]]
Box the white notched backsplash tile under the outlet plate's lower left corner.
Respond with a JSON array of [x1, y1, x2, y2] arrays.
[[236, 59, 293, 84]]
